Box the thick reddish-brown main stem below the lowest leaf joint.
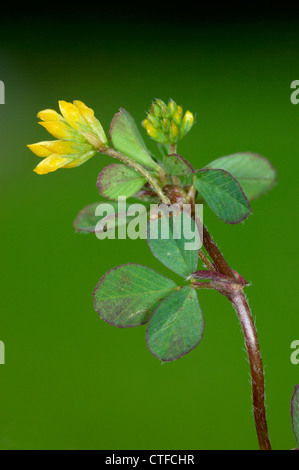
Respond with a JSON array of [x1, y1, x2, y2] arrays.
[[226, 289, 271, 450]]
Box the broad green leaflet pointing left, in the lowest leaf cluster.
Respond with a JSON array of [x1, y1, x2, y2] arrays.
[[93, 263, 176, 328]]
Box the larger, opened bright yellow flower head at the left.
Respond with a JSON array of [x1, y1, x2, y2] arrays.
[[27, 100, 107, 175]]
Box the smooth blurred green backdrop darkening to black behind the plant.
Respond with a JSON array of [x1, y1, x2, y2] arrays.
[[0, 12, 299, 450]]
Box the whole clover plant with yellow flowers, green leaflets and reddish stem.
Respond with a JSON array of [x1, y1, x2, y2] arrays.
[[28, 99, 299, 450]]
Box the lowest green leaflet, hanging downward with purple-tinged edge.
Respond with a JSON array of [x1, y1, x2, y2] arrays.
[[146, 286, 204, 361]]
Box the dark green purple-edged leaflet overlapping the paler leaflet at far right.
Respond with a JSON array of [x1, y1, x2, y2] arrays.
[[194, 169, 251, 224]]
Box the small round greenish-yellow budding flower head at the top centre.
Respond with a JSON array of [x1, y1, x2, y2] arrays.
[[142, 100, 194, 144]]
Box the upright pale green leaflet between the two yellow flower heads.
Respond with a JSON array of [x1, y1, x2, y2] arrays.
[[110, 108, 157, 169]]
